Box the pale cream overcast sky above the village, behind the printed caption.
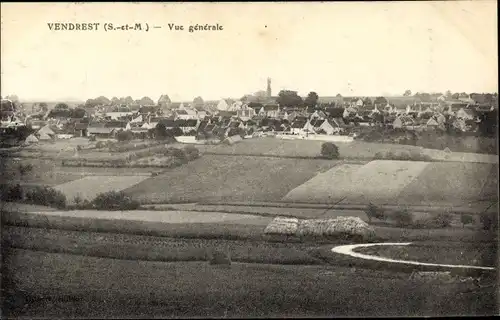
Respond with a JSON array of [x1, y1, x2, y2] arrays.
[[1, 0, 498, 101]]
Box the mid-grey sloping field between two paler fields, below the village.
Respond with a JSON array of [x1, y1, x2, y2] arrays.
[[126, 155, 338, 203]]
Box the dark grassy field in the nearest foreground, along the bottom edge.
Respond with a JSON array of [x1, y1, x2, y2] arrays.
[[3, 250, 493, 317]]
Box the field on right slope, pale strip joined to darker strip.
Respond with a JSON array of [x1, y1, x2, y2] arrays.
[[283, 160, 498, 206]]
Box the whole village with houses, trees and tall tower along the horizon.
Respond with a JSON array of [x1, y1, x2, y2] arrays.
[[2, 79, 498, 147]]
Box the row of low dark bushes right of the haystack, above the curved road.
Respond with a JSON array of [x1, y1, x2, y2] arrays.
[[365, 203, 498, 230]]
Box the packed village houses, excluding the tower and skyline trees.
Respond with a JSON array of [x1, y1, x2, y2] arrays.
[[19, 93, 495, 140]]
